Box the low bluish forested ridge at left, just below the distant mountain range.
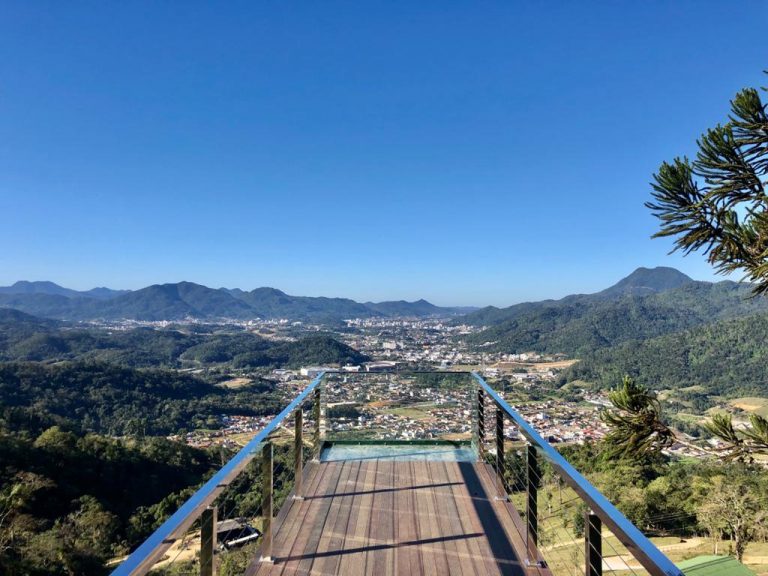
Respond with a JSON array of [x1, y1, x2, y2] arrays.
[[0, 310, 368, 368]]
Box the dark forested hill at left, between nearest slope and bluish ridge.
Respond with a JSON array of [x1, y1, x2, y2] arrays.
[[0, 362, 277, 436]]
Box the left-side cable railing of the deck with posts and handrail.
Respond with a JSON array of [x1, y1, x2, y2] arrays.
[[112, 374, 323, 576]]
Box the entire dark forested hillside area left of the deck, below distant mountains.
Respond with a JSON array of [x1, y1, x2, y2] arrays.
[[0, 310, 376, 576]]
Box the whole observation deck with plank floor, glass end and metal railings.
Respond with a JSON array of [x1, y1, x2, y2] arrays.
[[113, 372, 682, 576]]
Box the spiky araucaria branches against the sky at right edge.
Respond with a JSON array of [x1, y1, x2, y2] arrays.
[[646, 73, 768, 294]]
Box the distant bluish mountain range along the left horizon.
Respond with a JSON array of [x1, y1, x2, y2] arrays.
[[0, 282, 467, 322]]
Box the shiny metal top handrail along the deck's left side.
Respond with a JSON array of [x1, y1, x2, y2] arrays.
[[111, 372, 325, 576]]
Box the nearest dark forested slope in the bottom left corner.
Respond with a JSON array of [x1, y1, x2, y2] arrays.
[[0, 423, 221, 576]]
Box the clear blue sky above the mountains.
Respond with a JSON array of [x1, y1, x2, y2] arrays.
[[0, 0, 768, 305]]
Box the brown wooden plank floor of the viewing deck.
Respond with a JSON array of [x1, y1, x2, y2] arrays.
[[246, 460, 549, 576]]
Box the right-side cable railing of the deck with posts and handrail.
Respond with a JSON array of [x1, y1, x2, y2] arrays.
[[473, 373, 682, 576]]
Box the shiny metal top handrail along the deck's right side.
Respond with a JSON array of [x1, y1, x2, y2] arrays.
[[472, 372, 683, 576]]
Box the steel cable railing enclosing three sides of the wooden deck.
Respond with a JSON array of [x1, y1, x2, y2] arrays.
[[113, 372, 681, 576]]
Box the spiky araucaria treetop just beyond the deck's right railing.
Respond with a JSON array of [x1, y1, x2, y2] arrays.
[[600, 376, 674, 460]]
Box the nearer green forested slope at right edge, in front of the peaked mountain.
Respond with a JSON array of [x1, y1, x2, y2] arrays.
[[566, 313, 768, 402]]
